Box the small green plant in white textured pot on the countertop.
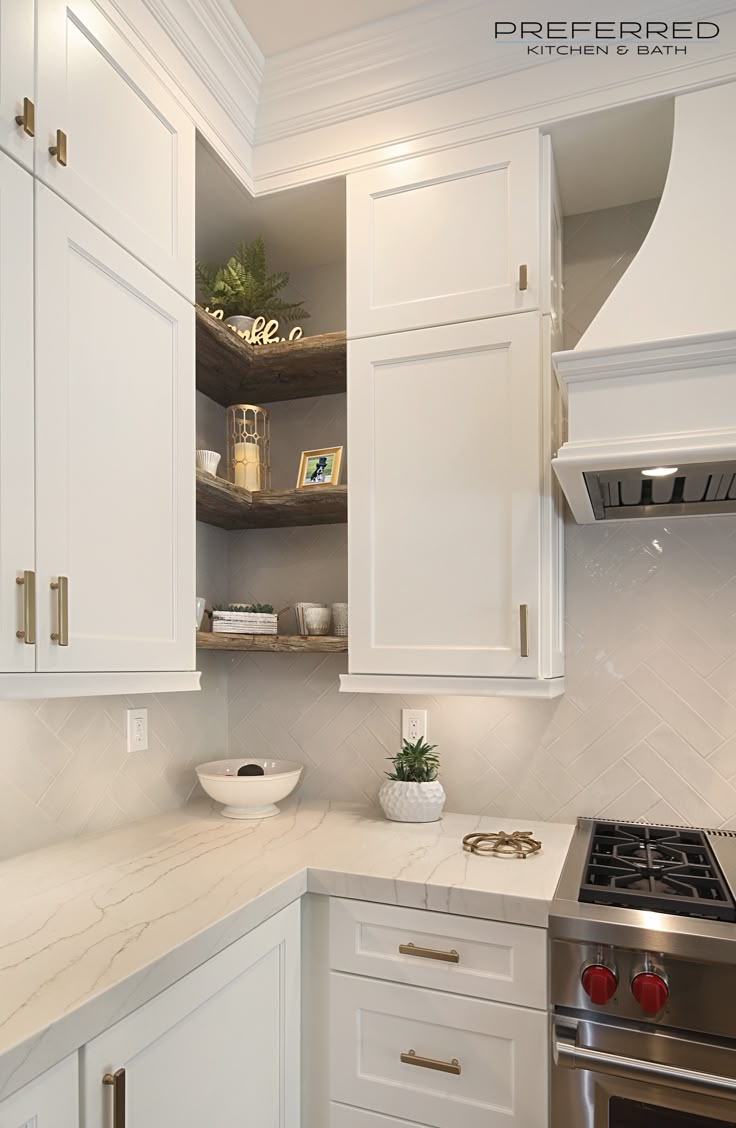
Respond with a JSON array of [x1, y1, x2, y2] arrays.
[[378, 738, 445, 822]]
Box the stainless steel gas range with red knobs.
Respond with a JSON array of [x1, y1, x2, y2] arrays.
[[550, 819, 736, 1128]]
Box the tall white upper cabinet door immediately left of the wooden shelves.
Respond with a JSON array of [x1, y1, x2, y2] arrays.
[[36, 185, 194, 671]]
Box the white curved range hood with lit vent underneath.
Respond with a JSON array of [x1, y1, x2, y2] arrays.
[[553, 82, 736, 522]]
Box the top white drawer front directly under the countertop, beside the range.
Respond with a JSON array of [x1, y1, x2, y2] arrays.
[[330, 898, 546, 1011]]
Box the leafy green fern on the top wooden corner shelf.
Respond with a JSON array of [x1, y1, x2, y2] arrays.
[[196, 236, 309, 333]]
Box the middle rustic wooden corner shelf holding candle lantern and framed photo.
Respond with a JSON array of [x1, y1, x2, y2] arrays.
[[196, 470, 348, 529]]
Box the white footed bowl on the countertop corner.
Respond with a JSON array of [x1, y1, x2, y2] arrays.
[[196, 756, 301, 819]]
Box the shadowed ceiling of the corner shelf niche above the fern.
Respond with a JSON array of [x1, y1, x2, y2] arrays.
[[196, 139, 345, 271]]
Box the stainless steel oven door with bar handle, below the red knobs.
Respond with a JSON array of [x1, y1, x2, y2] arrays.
[[552, 1015, 736, 1128]]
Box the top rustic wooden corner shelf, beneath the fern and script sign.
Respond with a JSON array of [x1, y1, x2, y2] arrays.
[[196, 306, 348, 407]]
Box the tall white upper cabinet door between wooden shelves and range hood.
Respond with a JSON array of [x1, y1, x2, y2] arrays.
[[348, 314, 542, 678]]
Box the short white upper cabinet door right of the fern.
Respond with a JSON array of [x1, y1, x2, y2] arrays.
[[348, 130, 540, 337]]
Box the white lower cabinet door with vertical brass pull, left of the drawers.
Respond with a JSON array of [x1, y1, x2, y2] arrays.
[[81, 902, 299, 1128]]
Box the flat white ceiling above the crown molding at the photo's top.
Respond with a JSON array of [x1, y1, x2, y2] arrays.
[[233, 0, 427, 55]]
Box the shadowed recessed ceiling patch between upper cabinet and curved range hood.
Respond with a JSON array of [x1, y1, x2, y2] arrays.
[[550, 98, 674, 215]]
